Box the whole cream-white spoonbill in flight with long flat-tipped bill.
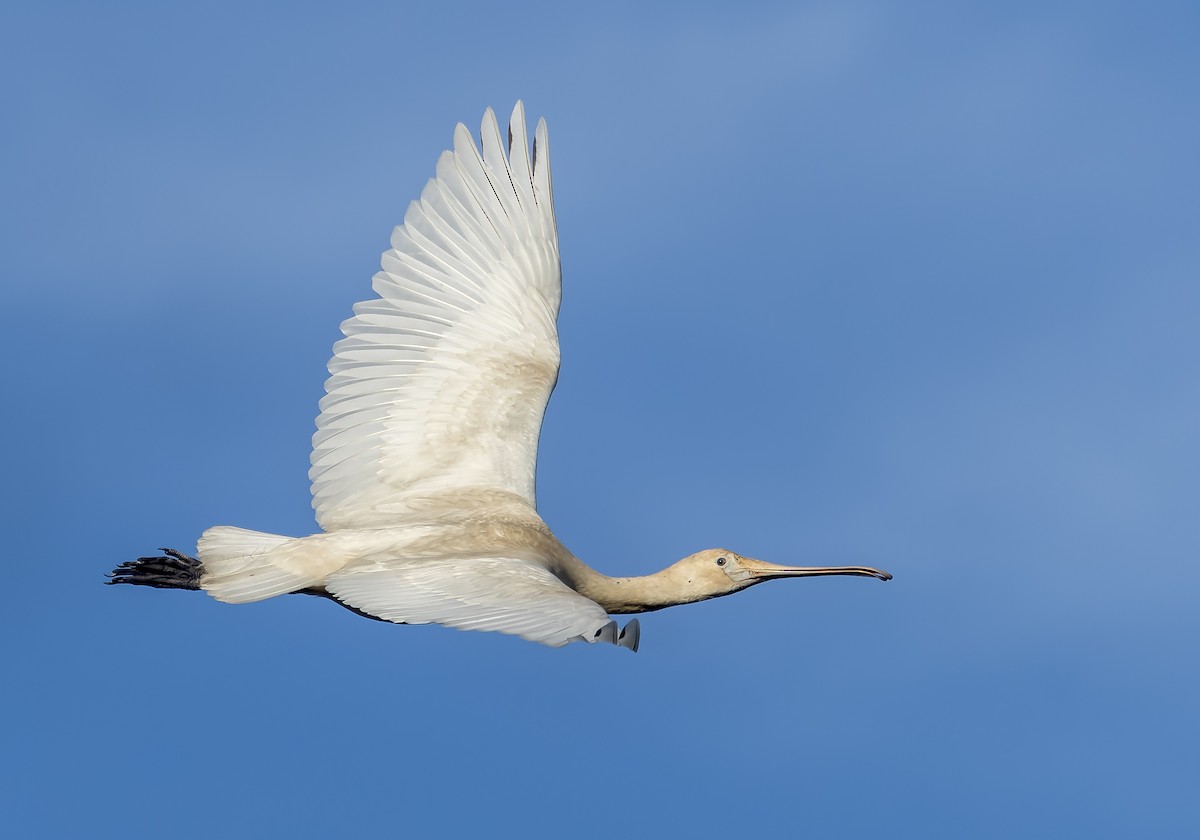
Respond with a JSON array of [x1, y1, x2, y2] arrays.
[[108, 102, 892, 650]]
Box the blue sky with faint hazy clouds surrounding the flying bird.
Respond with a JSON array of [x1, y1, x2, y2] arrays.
[[0, 1, 1200, 838]]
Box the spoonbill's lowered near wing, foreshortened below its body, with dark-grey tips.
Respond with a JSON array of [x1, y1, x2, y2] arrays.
[[325, 557, 616, 647]]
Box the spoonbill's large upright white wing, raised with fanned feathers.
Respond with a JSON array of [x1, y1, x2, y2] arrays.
[[308, 102, 562, 530]]
